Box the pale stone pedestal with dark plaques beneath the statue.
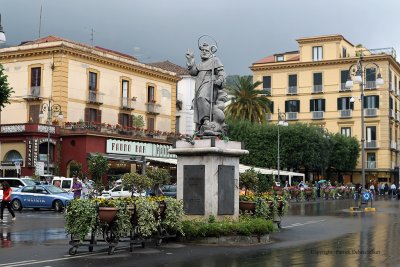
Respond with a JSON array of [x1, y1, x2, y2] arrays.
[[169, 138, 249, 219]]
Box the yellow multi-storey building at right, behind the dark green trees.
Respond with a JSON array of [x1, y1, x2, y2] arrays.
[[251, 34, 400, 183]]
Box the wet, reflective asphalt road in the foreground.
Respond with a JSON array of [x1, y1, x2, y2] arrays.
[[0, 198, 400, 267]]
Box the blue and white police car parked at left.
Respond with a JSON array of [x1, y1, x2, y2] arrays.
[[11, 185, 74, 212]]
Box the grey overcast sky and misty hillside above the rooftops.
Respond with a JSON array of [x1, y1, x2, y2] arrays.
[[0, 0, 400, 75]]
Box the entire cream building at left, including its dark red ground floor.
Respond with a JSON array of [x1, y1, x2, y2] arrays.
[[0, 36, 181, 176]]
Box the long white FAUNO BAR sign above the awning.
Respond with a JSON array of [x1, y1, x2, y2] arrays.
[[106, 139, 176, 158]]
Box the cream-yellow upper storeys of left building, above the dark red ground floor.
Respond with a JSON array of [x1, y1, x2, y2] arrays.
[[0, 36, 180, 132]]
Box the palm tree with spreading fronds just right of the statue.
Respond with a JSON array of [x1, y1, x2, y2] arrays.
[[225, 76, 271, 123]]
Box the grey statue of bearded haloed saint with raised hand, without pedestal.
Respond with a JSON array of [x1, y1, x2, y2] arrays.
[[186, 43, 228, 136]]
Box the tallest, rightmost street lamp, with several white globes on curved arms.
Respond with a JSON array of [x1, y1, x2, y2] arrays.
[[345, 51, 384, 193]]
